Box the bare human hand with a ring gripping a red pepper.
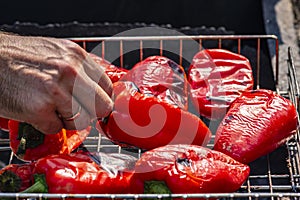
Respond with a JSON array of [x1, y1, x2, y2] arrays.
[[0, 33, 113, 133]]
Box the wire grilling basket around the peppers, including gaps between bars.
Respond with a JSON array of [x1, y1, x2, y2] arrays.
[[0, 35, 300, 200]]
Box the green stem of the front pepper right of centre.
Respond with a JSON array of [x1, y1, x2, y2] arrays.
[[144, 181, 172, 199]]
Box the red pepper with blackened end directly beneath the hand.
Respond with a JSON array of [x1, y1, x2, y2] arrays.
[[8, 120, 91, 161]]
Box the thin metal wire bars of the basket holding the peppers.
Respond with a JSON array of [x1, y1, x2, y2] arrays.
[[0, 35, 300, 199]]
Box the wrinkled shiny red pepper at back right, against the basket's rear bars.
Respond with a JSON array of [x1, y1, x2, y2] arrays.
[[188, 49, 254, 120]]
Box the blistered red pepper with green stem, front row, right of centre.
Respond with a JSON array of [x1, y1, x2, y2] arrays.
[[131, 144, 250, 194]]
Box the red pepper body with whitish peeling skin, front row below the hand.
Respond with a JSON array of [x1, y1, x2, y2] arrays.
[[34, 152, 136, 197]]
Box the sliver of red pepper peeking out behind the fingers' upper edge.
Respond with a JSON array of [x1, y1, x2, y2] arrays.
[[89, 53, 128, 83]]
